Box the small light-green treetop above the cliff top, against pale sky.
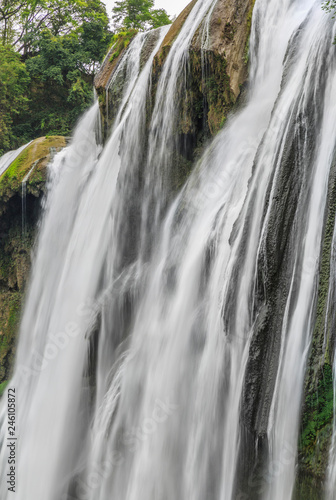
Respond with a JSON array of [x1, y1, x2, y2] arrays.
[[112, 0, 170, 31]]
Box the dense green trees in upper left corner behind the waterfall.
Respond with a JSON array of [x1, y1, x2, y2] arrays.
[[0, 0, 112, 155]]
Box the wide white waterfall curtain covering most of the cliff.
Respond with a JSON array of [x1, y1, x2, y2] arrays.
[[0, 0, 336, 500]]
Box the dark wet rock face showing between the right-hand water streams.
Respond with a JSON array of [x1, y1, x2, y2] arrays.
[[230, 19, 335, 500]]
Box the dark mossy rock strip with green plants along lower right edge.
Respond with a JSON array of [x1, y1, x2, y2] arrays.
[[298, 163, 336, 488]]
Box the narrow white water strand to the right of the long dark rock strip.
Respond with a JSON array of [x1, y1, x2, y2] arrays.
[[265, 6, 336, 500]]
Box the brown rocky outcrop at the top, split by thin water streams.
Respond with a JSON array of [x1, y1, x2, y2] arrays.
[[95, 0, 254, 141]]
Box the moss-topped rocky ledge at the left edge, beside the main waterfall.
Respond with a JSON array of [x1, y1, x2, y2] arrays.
[[0, 137, 66, 382]]
